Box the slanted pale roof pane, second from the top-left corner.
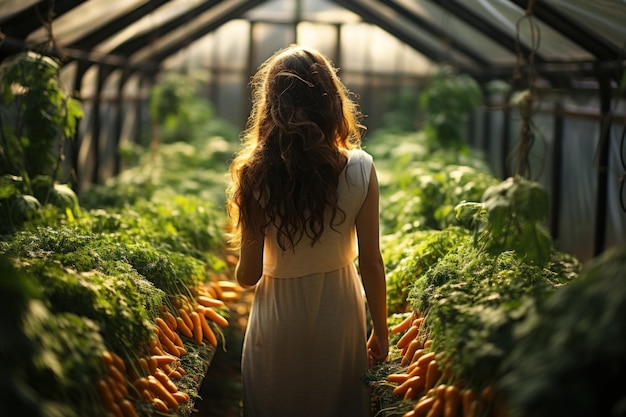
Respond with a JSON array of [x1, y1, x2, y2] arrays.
[[26, 0, 148, 45]]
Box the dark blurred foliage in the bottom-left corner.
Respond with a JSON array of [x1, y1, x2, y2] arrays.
[[0, 256, 104, 417]]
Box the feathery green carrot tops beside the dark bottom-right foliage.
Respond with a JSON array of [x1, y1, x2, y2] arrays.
[[409, 239, 580, 388]]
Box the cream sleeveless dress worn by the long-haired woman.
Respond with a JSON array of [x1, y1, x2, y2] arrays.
[[242, 149, 372, 417]]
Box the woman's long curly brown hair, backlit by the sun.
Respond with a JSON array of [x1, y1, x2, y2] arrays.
[[227, 45, 365, 250]]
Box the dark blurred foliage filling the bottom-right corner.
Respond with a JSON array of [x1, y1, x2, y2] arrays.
[[498, 248, 626, 417]]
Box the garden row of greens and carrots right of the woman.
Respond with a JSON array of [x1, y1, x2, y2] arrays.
[[364, 117, 626, 417]]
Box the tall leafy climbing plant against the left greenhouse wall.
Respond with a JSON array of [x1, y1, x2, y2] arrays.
[[0, 53, 83, 233]]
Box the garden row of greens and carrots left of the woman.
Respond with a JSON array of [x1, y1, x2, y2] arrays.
[[0, 54, 242, 417]]
